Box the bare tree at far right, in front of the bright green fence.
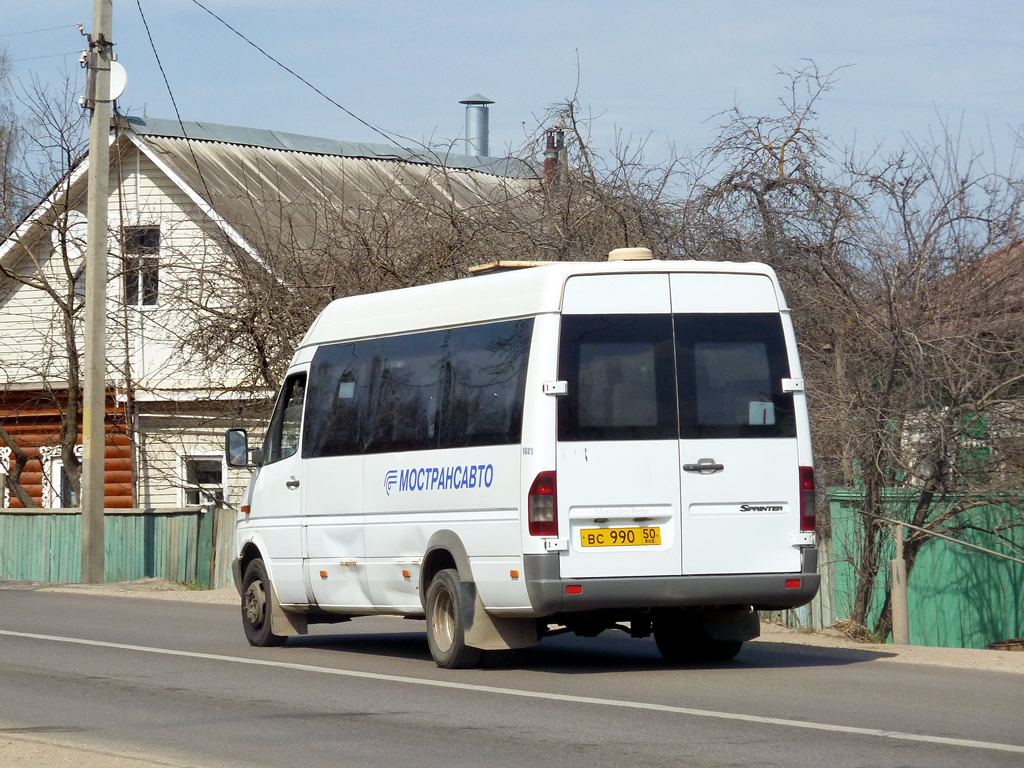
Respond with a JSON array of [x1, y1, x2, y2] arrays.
[[841, 131, 1024, 637]]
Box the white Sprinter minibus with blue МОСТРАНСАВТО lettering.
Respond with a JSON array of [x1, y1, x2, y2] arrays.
[[225, 249, 819, 668]]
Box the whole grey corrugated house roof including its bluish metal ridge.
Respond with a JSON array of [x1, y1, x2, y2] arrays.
[[122, 118, 537, 259]]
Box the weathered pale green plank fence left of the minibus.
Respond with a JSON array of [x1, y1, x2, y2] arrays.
[[0, 508, 224, 589]]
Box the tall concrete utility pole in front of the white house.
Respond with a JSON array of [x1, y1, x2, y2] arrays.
[[82, 0, 114, 584]]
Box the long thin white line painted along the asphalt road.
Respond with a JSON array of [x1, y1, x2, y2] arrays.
[[0, 630, 1024, 754]]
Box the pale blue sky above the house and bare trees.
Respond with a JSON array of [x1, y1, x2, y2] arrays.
[[0, 0, 1024, 166]]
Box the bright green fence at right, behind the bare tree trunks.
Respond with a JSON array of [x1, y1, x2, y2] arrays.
[[828, 489, 1024, 648]]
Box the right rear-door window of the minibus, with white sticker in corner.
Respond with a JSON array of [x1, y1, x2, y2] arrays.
[[676, 313, 797, 439]]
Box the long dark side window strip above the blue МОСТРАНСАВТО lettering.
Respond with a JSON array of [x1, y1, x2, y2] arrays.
[[302, 319, 534, 459]]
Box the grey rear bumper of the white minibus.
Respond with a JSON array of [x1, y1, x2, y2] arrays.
[[523, 547, 821, 616]]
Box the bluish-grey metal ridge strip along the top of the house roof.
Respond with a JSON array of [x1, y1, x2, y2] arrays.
[[126, 117, 538, 178]]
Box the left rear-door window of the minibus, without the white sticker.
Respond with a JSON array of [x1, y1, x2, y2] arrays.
[[558, 314, 677, 440]]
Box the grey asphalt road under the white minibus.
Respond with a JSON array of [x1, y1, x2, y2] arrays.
[[0, 589, 1024, 768]]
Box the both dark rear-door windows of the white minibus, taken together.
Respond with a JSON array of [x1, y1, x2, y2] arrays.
[[558, 312, 797, 441]]
